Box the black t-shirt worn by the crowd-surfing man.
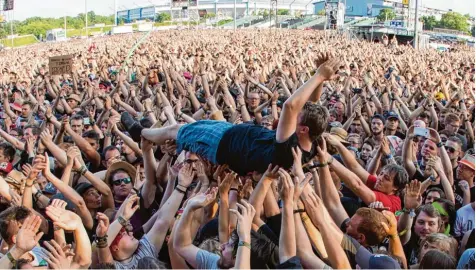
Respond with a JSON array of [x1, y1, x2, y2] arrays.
[[217, 124, 316, 175]]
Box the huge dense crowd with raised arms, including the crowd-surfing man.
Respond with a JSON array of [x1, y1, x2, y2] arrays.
[[0, 30, 475, 269]]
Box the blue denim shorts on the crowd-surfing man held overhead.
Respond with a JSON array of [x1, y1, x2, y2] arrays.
[[177, 120, 233, 164]]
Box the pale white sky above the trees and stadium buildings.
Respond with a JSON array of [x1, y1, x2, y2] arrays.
[[7, 0, 476, 20]]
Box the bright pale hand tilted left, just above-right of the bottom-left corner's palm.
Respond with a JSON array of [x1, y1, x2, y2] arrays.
[[46, 199, 83, 231]]
